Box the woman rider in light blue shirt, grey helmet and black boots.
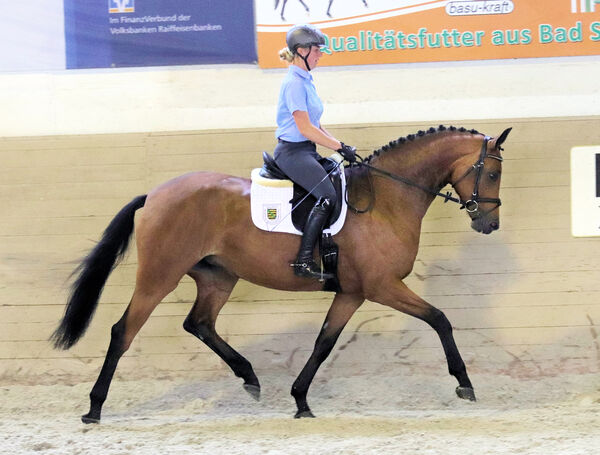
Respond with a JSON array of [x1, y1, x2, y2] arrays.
[[274, 25, 356, 279]]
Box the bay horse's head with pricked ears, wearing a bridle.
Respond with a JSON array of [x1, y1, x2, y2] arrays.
[[452, 128, 512, 234]]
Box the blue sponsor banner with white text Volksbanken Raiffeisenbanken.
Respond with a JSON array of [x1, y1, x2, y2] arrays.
[[65, 0, 256, 68]]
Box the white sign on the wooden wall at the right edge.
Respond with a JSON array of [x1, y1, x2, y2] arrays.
[[571, 145, 600, 237]]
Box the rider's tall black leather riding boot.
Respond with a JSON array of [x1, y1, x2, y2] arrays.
[[292, 198, 334, 280]]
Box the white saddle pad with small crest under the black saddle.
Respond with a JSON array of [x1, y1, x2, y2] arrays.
[[250, 154, 348, 235]]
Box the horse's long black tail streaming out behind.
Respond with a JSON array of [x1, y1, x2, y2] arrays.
[[50, 195, 146, 349]]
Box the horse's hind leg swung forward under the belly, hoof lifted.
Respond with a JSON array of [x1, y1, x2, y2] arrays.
[[183, 261, 260, 400]]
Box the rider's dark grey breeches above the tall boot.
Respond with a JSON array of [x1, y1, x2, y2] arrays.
[[273, 141, 335, 204]]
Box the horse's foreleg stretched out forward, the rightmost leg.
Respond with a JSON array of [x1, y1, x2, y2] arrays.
[[375, 283, 475, 401]]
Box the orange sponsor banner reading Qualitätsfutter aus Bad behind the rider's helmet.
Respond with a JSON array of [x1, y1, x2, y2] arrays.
[[256, 0, 600, 68]]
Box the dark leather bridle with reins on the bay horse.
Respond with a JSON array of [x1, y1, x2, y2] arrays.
[[346, 136, 503, 218]]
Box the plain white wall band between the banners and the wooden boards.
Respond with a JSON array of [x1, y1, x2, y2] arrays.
[[0, 57, 600, 137]]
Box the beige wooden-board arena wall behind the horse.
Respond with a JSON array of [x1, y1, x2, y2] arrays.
[[0, 117, 600, 382]]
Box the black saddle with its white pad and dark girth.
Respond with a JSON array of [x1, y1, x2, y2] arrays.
[[250, 152, 347, 292]]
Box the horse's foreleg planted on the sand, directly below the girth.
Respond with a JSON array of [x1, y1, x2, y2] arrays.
[[291, 294, 364, 418]]
